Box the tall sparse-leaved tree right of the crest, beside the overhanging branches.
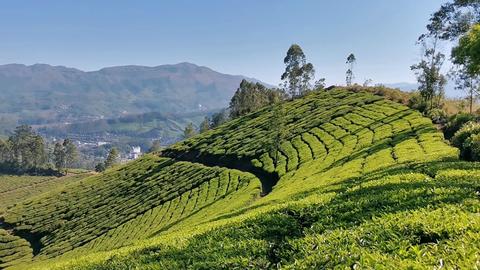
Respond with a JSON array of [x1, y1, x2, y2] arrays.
[[410, 38, 447, 110]]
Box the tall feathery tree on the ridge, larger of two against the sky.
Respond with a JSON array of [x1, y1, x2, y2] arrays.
[[281, 44, 315, 97]]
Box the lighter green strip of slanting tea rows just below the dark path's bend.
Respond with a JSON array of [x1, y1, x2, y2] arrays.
[[77, 170, 259, 251]]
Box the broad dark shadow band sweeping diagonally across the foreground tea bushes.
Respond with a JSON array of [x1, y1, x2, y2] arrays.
[[110, 159, 480, 269]]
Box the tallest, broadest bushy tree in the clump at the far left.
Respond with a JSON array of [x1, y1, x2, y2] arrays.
[[8, 125, 46, 170]]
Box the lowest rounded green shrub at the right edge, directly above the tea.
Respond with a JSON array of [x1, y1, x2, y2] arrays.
[[452, 122, 480, 160]]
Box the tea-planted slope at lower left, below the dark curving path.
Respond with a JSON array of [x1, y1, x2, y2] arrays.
[[0, 156, 253, 257]]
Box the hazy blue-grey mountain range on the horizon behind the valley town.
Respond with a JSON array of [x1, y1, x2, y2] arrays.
[[0, 63, 270, 133]]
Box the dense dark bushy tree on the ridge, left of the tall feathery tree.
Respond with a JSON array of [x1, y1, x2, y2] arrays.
[[229, 80, 283, 119]]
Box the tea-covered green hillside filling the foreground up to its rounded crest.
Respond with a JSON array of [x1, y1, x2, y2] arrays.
[[0, 88, 480, 269]]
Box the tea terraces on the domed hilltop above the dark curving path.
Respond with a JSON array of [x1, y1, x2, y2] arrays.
[[164, 90, 457, 184]]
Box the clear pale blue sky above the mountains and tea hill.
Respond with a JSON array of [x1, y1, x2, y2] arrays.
[[0, 0, 450, 84]]
